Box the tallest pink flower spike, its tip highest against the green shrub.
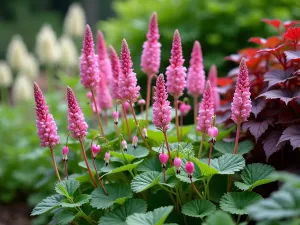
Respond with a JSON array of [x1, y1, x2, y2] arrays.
[[141, 12, 161, 76]]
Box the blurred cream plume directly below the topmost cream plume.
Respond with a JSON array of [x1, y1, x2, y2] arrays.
[[59, 35, 79, 69]]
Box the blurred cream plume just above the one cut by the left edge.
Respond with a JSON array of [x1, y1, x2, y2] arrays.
[[6, 35, 27, 71]]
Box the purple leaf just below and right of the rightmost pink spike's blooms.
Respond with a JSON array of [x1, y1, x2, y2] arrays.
[[243, 119, 273, 142]]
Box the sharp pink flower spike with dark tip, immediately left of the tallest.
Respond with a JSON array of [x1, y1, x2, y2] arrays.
[[119, 39, 141, 103]]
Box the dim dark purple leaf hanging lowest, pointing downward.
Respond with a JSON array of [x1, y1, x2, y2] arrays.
[[263, 131, 284, 161]]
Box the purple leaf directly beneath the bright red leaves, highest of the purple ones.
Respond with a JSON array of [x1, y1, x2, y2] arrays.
[[265, 68, 296, 89]]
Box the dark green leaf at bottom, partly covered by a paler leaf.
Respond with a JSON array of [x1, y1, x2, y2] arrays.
[[99, 199, 147, 225]]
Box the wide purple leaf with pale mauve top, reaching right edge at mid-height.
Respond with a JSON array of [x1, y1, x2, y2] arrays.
[[258, 89, 300, 105]]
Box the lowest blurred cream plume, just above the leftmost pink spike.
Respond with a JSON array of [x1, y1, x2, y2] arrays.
[[12, 73, 33, 104]]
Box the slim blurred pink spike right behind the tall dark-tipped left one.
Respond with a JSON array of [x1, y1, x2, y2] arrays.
[[97, 30, 112, 85]]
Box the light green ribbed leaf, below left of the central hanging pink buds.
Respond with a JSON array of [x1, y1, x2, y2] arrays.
[[131, 171, 160, 193]]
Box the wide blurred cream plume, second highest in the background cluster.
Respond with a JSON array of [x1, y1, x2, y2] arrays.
[[36, 24, 60, 65]]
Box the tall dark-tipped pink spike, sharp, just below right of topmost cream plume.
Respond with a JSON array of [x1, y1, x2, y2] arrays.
[[80, 25, 100, 89]]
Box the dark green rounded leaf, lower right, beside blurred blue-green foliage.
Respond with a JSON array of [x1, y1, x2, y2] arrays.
[[220, 191, 262, 215]]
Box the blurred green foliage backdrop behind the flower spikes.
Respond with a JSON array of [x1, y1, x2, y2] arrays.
[[0, 0, 300, 224]]
